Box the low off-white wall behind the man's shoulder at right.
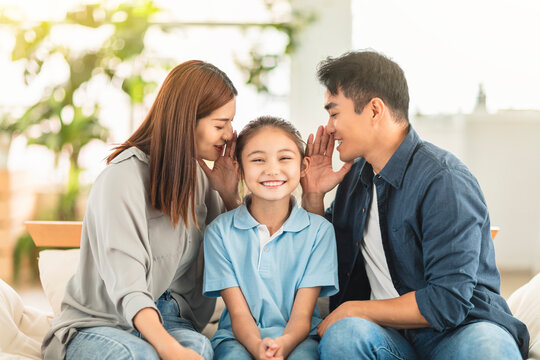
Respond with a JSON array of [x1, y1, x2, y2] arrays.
[[415, 111, 540, 273]]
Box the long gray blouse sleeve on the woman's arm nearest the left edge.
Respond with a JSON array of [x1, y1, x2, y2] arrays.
[[85, 161, 159, 326]]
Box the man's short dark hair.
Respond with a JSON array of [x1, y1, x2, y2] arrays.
[[317, 51, 409, 124]]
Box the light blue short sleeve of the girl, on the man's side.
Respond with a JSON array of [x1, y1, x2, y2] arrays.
[[298, 220, 339, 296]]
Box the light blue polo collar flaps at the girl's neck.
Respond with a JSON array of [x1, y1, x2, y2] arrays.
[[233, 196, 309, 232]]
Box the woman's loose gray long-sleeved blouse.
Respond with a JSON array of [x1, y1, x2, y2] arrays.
[[42, 147, 225, 359]]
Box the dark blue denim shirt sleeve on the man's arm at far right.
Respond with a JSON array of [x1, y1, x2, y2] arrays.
[[416, 169, 489, 331]]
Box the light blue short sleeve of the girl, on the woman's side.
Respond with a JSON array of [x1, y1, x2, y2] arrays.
[[203, 222, 239, 297]]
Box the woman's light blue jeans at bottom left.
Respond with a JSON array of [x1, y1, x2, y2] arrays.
[[66, 290, 214, 360]]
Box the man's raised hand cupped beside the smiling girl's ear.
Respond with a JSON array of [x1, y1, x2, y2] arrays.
[[300, 126, 353, 202]]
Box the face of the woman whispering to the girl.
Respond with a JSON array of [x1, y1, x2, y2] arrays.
[[195, 98, 236, 161]]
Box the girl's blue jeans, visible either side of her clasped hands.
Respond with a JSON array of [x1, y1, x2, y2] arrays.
[[214, 336, 319, 360]]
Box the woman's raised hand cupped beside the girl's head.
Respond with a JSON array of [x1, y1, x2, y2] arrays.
[[197, 131, 240, 210]]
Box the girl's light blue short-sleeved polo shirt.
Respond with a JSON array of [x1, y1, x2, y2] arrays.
[[203, 198, 338, 348]]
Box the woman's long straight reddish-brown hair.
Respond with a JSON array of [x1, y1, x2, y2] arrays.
[[107, 60, 237, 226]]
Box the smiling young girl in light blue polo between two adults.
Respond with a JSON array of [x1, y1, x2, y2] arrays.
[[204, 117, 338, 360]]
